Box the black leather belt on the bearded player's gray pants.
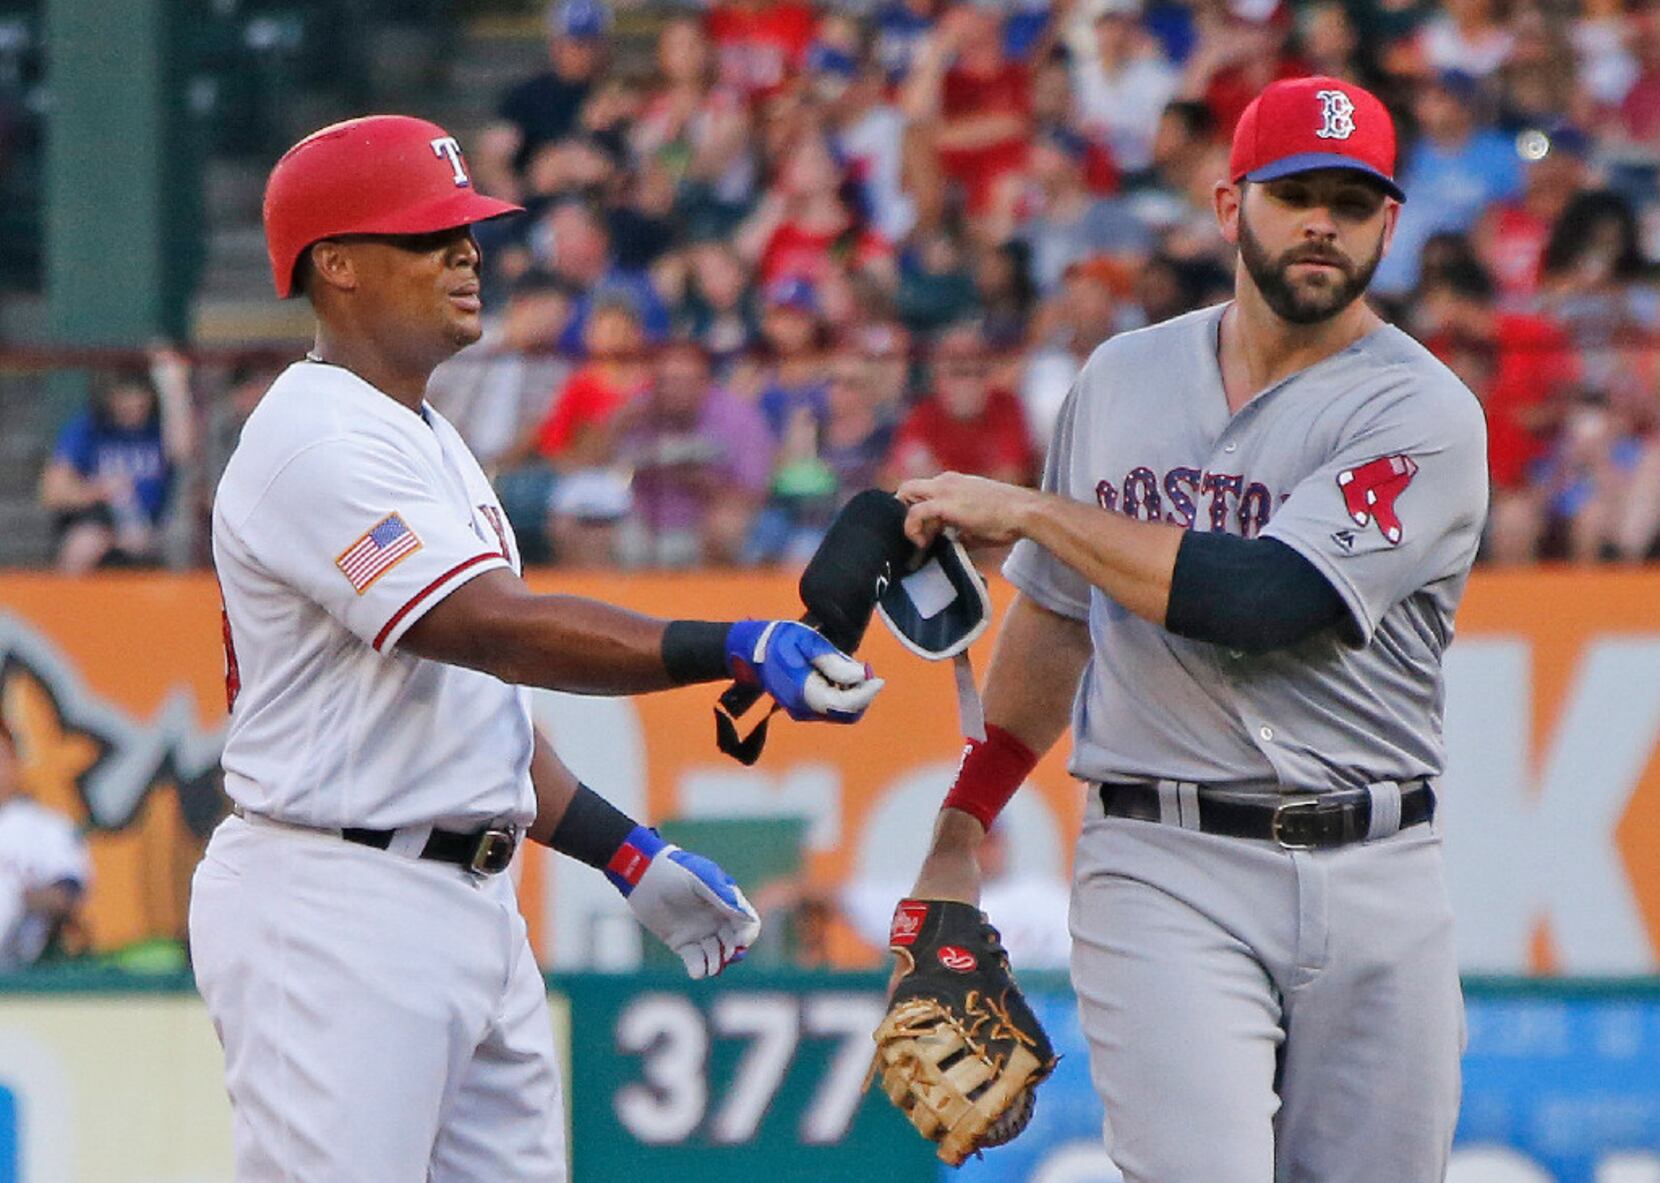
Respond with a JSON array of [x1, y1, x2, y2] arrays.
[[1097, 780, 1436, 850]]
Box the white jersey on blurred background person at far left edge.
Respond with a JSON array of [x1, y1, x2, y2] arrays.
[[0, 796, 91, 972]]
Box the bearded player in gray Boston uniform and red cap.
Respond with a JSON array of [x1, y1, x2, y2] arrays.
[[900, 78, 1487, 1183]]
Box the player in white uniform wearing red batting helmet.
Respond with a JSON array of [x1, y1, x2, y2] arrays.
[[191, 116, 881, 1183]]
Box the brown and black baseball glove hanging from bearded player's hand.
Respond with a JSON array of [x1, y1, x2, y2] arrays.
[[865, 899, 1056, 1166]]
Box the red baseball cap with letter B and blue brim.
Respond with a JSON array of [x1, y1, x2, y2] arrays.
[[1228, 75, 1406, 201]]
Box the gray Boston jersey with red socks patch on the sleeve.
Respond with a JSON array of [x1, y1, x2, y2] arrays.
[[1004, 305, 1487, 790]]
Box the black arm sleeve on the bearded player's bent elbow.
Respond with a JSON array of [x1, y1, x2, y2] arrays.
[[1164, 529, 1348, 654]]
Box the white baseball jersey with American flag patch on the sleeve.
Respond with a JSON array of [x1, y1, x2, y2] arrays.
[[212, 362, 536, 830]]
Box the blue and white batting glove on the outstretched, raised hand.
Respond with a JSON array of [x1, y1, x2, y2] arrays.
[[727, 621, 883, 723]]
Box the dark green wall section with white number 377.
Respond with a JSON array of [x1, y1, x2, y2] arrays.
[[554, 974, 938, 1183]]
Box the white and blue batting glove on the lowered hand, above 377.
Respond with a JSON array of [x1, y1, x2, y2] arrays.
[[606, 826, 760, 977]]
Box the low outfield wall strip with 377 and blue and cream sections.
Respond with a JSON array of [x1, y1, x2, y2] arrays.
[[0, 967, 1660, 1183]]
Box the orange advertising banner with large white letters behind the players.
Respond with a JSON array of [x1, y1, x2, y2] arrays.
[[0, 571, 1660, 972]]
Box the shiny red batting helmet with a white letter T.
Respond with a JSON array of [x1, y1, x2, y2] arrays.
[[264, 114, 520, 299]]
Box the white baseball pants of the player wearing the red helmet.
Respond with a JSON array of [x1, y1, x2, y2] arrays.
[[189, 816, 566, 1183]]
